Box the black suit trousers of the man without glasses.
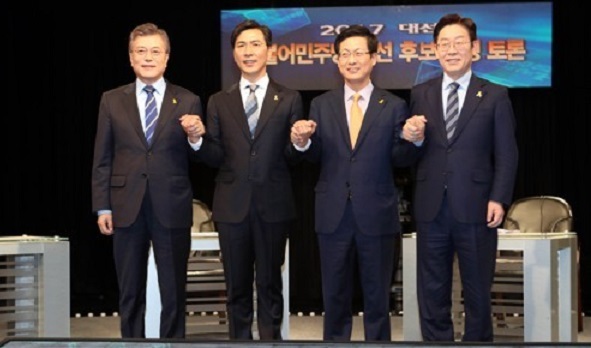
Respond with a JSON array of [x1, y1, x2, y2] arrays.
[[216, 204, 289, 340]]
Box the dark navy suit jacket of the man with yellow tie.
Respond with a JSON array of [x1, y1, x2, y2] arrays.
[[305, 88, 418, 235]]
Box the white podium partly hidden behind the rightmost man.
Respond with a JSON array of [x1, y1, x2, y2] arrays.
[[402, 232, 578, 342]]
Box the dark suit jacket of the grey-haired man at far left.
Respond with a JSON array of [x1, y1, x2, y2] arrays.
[[92, 83, 203, 228]]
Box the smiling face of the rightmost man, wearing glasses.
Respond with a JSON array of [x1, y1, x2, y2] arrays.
[[436, 24, 476, 80]]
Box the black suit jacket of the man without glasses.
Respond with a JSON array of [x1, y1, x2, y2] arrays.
[[197, 80, 303, 223]]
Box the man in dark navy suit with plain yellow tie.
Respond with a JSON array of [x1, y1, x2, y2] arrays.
[[291, 25, 418, 341]]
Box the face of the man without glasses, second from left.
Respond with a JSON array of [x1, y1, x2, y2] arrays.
[[234, 29, 269, 82]]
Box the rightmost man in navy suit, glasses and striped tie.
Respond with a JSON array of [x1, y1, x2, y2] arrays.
[[404, 14, 518, 341]]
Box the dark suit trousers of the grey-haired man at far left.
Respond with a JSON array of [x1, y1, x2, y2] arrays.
[[113, 194, 191, 338]]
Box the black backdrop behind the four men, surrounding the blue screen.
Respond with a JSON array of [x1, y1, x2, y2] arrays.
[[0, 0, 591, 313]]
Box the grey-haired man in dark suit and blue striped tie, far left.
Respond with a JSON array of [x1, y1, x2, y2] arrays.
[[92, 23, 203, 338]]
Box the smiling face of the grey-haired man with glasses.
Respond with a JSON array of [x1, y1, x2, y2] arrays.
[[129, 35, 169, 84]]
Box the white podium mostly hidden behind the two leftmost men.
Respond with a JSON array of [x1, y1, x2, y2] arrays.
[[145, 232, 289, 339]]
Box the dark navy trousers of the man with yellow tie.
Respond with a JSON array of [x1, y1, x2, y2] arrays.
[[317, 202, 399, 341]]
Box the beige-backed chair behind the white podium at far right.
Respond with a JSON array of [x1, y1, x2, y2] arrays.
[[492, 196, 583, 336]]
